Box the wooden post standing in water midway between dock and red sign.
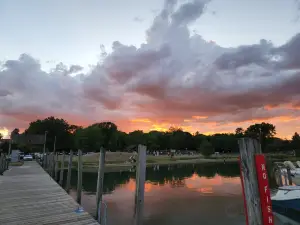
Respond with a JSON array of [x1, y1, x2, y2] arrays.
[[134, 145, 147, 225]]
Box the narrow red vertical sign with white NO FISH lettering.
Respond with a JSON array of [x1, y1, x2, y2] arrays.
[[255, 154, 274, 225]]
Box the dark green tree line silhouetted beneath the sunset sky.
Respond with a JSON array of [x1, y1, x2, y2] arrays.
[[0, 117, 300, 154]]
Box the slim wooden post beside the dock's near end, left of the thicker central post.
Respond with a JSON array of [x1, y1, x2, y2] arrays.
[[96, 147, 105, 223]]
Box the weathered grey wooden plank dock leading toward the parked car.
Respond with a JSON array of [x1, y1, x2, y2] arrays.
[[0, 161, 99, 225]]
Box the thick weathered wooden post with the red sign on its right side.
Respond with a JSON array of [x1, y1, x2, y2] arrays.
[[238, 138, 263, 225]]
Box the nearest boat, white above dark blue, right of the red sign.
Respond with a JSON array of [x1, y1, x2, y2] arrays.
[[271, 186, 300, 222]]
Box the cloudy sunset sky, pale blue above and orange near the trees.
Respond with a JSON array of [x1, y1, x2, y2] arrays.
[[0, 0, 300, 137]]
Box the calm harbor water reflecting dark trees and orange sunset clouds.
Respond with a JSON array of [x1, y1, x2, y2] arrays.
[[59, 164, 298, 225]]
